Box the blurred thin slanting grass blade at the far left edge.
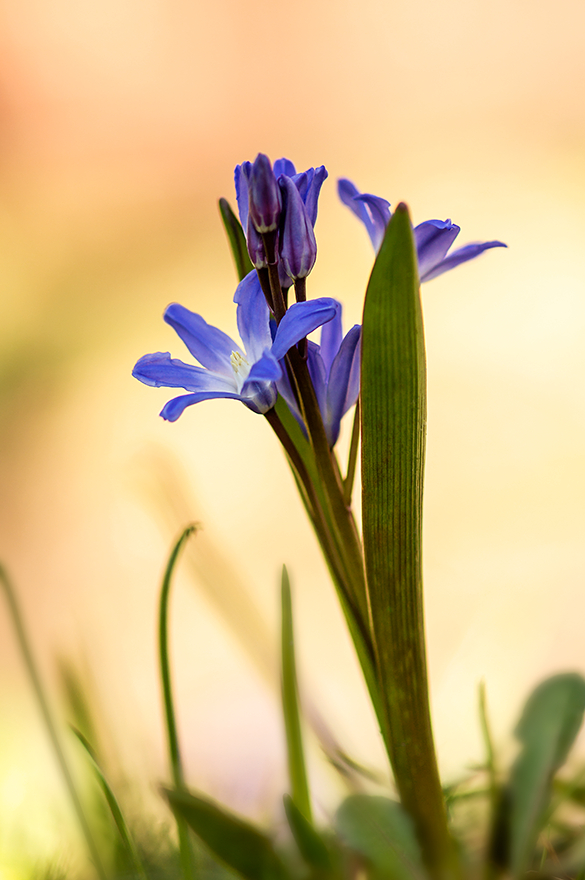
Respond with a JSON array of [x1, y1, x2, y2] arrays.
[[0, 565, 107, 880]]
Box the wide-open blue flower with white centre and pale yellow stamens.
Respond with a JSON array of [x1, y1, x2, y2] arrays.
[[132, 271, 340, 422]]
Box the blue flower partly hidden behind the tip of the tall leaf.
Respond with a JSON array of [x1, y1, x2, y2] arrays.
[[338, 178, 507, 282]]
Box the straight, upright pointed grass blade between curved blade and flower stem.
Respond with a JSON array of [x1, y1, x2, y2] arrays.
[[281, 566, 312, 823]]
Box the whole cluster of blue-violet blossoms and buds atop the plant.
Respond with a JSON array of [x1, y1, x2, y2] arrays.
[[133, 153, 505, 447]]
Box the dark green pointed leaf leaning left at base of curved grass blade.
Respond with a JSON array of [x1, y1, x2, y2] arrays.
[[163, 789, 288, 880]]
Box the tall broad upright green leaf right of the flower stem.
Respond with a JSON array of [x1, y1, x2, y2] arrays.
[[360, 205, 455, 874]]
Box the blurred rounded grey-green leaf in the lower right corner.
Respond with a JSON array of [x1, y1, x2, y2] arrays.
[[509, 673, 585, 877]]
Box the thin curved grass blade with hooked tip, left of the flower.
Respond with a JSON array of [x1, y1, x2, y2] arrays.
[[158, 525, 197, 880]]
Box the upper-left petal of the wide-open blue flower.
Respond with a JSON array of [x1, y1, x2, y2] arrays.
[[164, 303, 243, 376]]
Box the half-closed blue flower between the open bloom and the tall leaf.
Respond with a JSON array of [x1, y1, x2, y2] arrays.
[[277, 305, 362, 447]]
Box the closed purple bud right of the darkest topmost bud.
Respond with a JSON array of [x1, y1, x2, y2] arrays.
[[278, 175, 317, 278]]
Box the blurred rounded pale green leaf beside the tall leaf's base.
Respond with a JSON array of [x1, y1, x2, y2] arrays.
[[336, 794, 426, 880]]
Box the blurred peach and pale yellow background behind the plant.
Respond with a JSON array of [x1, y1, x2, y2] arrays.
[[0, 0, 585, 878]]
